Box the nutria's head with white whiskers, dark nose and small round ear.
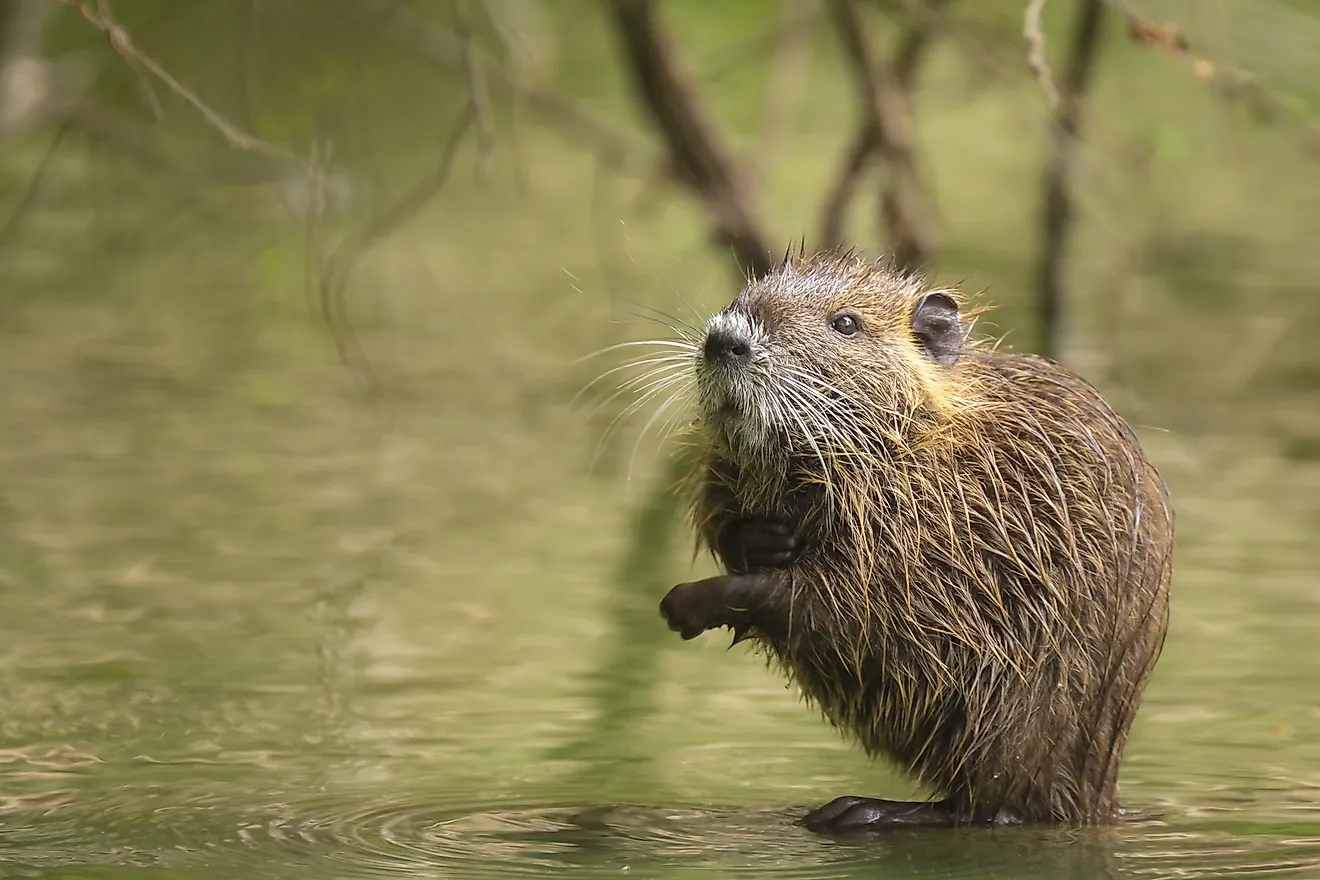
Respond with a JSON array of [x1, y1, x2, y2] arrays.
[[694, 255, 969, 466]]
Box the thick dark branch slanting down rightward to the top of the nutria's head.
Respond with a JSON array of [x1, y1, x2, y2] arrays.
[[609, 0, 774, 276]]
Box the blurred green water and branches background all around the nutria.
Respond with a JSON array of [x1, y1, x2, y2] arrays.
[[0, 0, 1320, 877]]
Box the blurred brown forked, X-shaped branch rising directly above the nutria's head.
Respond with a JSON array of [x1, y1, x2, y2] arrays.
[[821, 0, 936, 269]]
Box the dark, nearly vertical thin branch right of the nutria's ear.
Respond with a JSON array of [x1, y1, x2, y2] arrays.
[[1038, 0, 1105, 358]]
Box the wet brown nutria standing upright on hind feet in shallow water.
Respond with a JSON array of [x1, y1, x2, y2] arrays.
[[661, 253, 1173, 831]]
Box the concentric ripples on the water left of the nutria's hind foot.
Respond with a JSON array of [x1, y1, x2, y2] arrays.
[[224, 800, 859, 877]]
